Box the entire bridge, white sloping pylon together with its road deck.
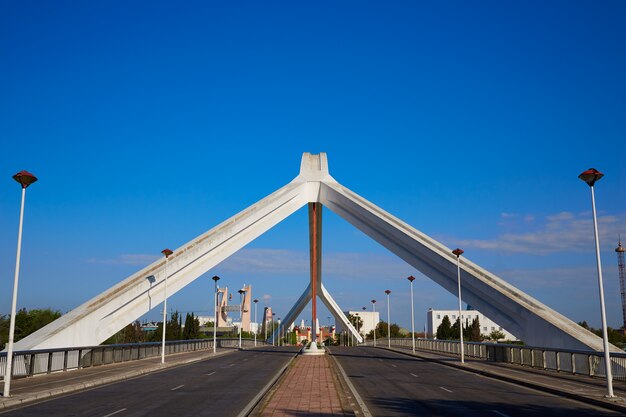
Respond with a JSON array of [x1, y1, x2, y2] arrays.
[[2, 153, 626, 416]]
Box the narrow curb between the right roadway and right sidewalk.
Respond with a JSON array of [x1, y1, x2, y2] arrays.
[[370, 346, 626, 413]]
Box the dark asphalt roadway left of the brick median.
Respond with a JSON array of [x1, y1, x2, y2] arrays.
[[1, 347, 297, 417]]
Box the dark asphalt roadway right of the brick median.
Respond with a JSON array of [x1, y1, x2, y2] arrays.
[[331, 347, 621, 417]]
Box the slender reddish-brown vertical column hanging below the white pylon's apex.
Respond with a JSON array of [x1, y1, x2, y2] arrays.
[[309, 203, 322, 342]]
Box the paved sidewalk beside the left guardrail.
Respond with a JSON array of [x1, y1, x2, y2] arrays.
[[0, 349, 236, 410]]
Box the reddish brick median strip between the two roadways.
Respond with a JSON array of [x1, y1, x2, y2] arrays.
[[256, 355, 355, 417]]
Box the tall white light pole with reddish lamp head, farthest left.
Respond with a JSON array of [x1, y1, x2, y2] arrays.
[[2, 171, 37, 397]]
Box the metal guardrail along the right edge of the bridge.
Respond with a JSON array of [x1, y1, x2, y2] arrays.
[[364, 338, 626, 381]]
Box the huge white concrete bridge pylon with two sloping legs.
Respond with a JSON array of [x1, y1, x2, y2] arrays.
[[15, 153, 602, 351]]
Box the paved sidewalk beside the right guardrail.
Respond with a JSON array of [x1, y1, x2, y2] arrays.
[[378, 346, 626, 414]]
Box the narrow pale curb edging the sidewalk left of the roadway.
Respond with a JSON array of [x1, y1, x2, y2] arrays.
[[0, 349, 237, 410]]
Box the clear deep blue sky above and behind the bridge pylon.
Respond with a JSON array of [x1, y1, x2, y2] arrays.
[[0, 1, 626, 327]]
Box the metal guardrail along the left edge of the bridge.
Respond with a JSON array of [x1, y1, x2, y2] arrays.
[[0, 338, 268, 379]]
